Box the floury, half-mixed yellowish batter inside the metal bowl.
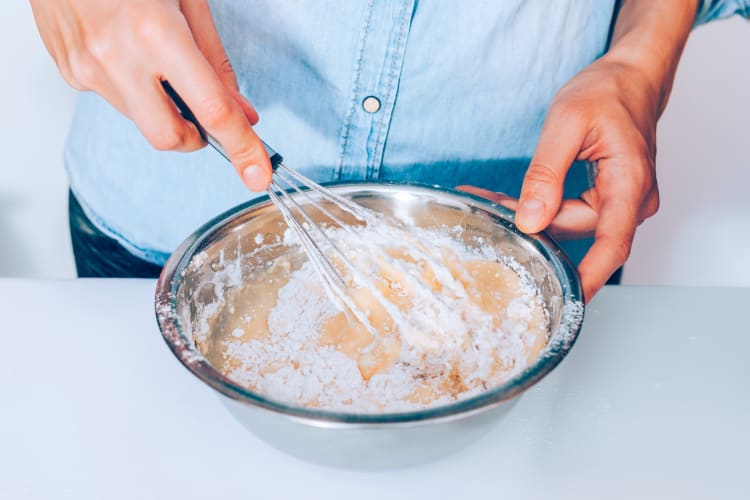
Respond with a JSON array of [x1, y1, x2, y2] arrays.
[[198, 228, 548, 413]]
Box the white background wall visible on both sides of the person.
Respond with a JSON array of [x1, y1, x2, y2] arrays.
[[0, 1, 750, 286]]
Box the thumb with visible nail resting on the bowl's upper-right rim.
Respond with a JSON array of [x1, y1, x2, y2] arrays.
[[516, 106, 586, 233]]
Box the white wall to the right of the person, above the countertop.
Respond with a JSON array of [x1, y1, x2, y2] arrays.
[[623, 18, 750, 286]]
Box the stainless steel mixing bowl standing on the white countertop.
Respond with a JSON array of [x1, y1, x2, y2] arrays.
[[155, 183, 583, 468]]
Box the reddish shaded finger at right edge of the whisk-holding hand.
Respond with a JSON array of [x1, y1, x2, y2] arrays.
[[181, 0, 258, 125]]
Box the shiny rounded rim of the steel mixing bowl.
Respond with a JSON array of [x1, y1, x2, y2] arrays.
[[154, 181, 584, 428]]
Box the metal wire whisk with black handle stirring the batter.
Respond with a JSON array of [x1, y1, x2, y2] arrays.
[[162, 81, 466, 345]]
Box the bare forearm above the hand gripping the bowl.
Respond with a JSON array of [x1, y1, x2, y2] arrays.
[[606, 0, 700, 114]]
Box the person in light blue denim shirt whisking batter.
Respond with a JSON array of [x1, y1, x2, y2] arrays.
[[31, 0, 750, 300]]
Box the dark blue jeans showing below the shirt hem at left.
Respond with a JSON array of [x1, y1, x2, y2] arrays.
[[68, 191, 161, 278]]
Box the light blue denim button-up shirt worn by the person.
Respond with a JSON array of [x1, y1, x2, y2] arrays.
[[65, 0, 750, 264]]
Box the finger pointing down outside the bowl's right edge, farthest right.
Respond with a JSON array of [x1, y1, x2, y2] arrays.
[[578, 196, 638, 302]]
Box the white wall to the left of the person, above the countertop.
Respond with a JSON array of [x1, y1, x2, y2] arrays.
[[0, 0, 75, 278]]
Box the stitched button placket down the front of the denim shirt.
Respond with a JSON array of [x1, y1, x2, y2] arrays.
[[336, 0, 415, 180]]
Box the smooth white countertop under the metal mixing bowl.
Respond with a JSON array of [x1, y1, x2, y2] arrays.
[[0, 280, 750, 500]]
